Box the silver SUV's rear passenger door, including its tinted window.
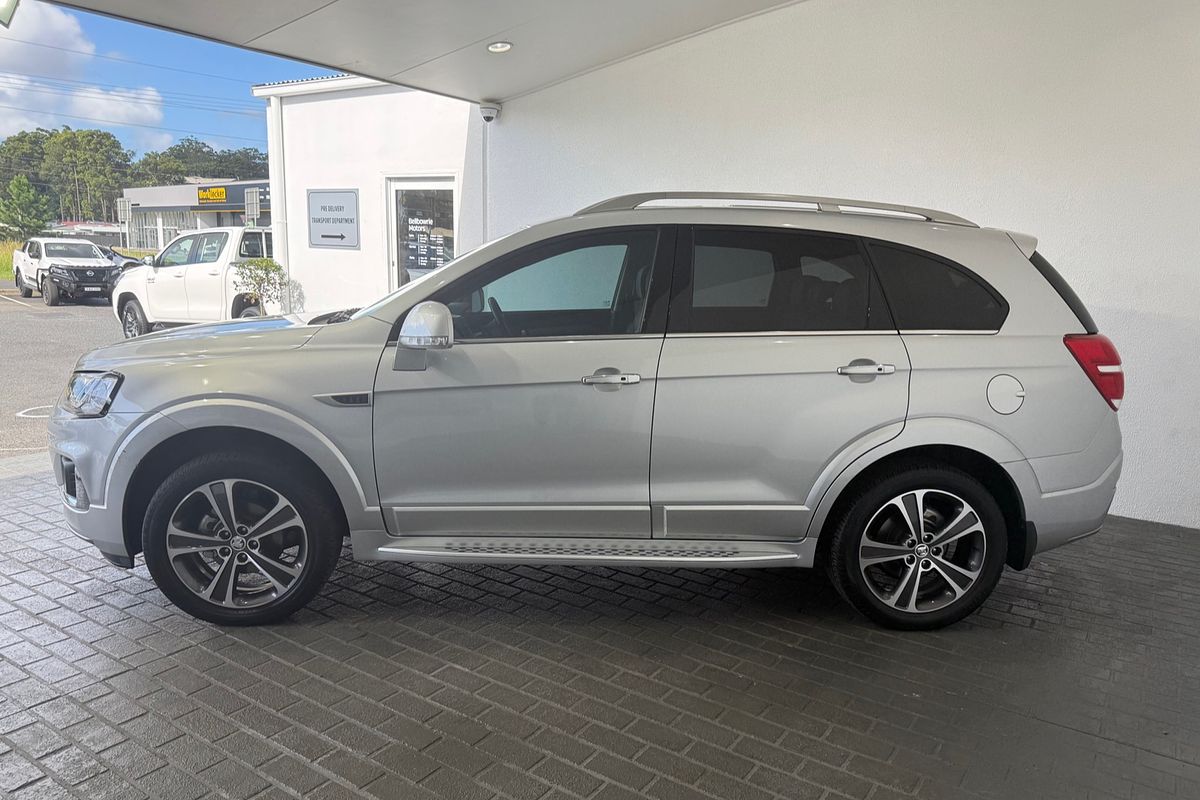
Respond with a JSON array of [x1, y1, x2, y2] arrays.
[[650, 227, 908, 540]]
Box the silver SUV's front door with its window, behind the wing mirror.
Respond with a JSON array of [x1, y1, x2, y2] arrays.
[[373, 227, 674, 537]]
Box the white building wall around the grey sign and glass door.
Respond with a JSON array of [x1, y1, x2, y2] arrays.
[[270, 86, 480, 312]]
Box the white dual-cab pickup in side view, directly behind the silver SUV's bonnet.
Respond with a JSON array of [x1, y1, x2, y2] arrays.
[[113, 228, 275, 338]]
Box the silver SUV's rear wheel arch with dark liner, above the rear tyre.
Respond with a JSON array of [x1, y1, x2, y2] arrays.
[[808, 420, 1037, 570]]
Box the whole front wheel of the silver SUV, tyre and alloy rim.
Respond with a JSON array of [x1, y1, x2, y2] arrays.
[[142, 453, 344, 625]]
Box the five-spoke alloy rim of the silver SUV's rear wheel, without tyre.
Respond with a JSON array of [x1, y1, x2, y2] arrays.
[[858, 489, 988, 614]]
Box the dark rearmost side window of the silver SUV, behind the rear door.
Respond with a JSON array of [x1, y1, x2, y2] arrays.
[[870, 242, 1008, 331]]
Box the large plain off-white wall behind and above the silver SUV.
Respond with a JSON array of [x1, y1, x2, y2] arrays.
[[487, 0, 1200, 527]]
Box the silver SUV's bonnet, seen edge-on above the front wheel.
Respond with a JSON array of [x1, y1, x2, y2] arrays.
[[76, 314, 320, 369]]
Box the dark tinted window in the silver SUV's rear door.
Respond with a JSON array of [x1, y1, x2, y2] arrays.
[[677, 228, 888, 333]]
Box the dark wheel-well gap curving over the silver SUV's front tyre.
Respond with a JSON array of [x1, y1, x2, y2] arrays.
[[121, 426, 349, 557]]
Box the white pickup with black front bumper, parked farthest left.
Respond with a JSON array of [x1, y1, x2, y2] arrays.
[[12, 236, 121, 306]]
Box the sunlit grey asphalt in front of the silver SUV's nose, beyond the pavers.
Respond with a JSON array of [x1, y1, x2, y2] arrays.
[[0, 295, 121, 458]]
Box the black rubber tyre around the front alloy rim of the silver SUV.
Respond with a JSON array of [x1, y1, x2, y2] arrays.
[[142, 452, 346, 625]]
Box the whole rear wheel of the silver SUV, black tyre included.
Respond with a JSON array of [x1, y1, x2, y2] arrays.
[[827, 462, 1008, 631]]
